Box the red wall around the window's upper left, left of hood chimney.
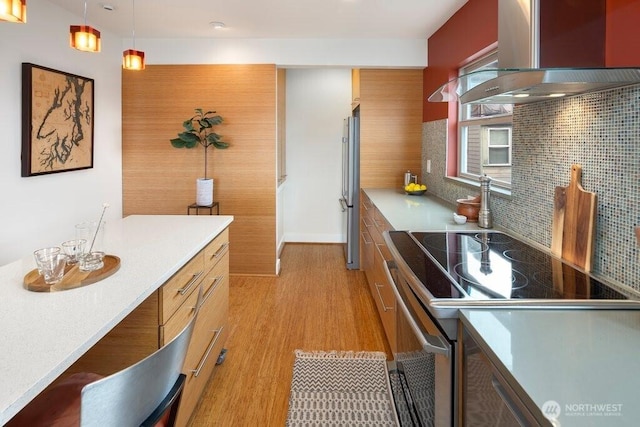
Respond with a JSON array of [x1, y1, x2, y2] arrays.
[[422, 0, 500, 122]]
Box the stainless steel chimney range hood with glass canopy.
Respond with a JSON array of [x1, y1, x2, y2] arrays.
[[429, 0, 640, 104]]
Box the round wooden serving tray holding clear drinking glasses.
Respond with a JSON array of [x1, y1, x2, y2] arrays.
[[24, 255, 120, 292]]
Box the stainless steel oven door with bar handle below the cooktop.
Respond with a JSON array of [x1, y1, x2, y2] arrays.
[[385, 262, 456, 427]]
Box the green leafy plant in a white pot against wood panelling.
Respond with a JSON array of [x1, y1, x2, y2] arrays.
[[171, 108, 229, 206]]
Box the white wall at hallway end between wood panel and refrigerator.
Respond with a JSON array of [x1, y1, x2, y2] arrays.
[[281, 68, 351, 242]]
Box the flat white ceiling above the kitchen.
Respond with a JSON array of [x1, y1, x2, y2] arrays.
[[43, 0, 467, 39]]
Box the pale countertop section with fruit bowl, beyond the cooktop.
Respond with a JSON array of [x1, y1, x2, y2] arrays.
[[364, 188, 480, 231]]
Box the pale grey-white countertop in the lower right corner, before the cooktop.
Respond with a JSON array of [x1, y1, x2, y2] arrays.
[[460, 309, 640, 427]]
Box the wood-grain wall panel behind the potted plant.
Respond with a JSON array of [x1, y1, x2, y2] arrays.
[[122, 65, 276, 275]]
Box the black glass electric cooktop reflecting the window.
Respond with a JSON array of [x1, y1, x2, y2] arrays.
[[389, 231, 628, 300]]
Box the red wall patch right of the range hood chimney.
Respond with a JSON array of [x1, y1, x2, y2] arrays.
[[605, 0, 640, 67]]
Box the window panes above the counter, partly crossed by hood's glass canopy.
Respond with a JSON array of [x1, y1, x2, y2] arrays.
[[458, 52, 513, 188]]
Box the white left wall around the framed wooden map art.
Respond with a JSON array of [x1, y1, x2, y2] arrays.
[[0, 0, 122, 266]]
